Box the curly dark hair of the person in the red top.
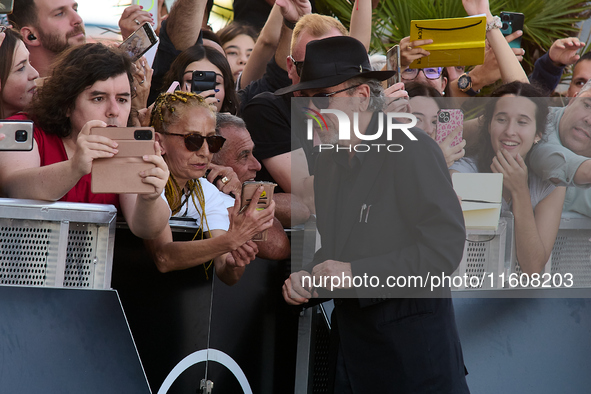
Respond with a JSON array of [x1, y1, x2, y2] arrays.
[[30, 44, 134, 138]]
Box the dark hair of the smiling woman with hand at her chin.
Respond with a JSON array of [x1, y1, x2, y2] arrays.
[[467, 81, 548, 172]]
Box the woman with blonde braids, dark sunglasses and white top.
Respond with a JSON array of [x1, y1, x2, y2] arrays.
[[146, 91, 275, 285]]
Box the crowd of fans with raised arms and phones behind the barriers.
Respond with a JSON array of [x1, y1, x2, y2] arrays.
[[0, 0, 591, 388]]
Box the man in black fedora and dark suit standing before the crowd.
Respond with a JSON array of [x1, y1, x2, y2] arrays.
[[277, 37, 469, 394]]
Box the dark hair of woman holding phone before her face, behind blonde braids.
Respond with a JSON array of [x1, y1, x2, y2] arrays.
[[162, 45, 239, 115]]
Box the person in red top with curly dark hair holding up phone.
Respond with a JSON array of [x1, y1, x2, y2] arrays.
[[0, 44, 170, 239]]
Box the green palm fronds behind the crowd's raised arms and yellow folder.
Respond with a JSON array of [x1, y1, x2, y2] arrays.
[[316, 0, 591, 71]]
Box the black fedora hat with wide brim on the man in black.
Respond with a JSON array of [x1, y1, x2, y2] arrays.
[[275, 36, 394, 96]]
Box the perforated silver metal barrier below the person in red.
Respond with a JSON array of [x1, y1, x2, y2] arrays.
[[0, 199, 117, 289]]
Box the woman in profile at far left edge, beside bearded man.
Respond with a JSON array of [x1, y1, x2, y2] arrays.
[[0, 26, 39, 119]]
